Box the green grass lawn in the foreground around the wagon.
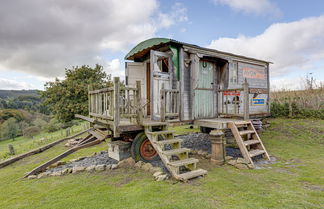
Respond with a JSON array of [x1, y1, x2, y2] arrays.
[[0, 119, 324, 209]]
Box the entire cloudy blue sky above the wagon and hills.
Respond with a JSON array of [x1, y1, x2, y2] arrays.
[[0, 0, 324, 90]]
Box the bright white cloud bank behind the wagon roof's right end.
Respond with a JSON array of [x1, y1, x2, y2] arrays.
[[209, 16, 324, 76]]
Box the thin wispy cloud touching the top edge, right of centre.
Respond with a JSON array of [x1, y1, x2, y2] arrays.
[[212, 0, 281, 16]]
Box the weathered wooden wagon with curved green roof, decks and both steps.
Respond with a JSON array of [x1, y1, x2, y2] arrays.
[[77, 38, 269, 180]]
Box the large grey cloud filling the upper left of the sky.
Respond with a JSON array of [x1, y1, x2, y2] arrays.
[[0, 0, 188, 78]]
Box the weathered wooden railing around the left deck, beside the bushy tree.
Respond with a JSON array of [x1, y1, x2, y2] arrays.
[[88, 77, 143, 137]]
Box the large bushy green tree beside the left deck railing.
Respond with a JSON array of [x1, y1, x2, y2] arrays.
[[42, 65, 111, 122]]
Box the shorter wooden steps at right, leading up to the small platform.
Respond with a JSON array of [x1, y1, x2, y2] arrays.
[[228, 121, 270, 166]]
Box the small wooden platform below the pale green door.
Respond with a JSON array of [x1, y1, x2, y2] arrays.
[[194, 118, 244, 129]]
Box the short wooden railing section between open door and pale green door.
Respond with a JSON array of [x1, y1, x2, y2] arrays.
[[160, 84, 180, 121]]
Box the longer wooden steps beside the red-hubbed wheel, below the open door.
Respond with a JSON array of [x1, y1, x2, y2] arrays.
[[145, 122, 207, 181]]
